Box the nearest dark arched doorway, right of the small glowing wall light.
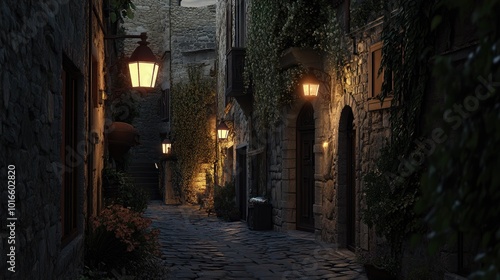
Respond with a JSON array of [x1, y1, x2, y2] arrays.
[[337, 106, 356, 250]]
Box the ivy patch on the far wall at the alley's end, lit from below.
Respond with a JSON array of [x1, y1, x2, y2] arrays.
[[172, 66, 215, 203]]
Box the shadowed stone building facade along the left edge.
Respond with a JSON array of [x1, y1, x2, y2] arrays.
[[0, 0, 106, 279]]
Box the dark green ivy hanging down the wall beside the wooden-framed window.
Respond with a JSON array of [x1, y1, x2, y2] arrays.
[[363, 0, 435, 259]]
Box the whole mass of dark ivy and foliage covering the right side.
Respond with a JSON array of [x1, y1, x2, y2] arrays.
[[363, 0, 500, 279]]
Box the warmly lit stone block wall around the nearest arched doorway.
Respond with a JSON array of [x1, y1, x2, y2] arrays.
[[316, 21, 390, 249]]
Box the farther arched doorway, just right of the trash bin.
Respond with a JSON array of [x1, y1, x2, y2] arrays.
[[296, 103, 314, 231]]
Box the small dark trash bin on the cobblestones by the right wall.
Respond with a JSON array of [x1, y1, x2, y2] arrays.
[[247, 197, 273, 230]]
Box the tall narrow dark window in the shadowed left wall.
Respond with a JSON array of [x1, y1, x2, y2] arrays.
[[61, 58, 80, 246]]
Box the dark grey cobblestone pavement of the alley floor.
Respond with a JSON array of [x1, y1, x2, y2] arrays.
[[146, 201, 367, 280]]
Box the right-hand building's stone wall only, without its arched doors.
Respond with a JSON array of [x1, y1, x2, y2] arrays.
[[213, 0, 389, 249]]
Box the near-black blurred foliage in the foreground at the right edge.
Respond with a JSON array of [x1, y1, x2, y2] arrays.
[[417, 0, 500, 279]]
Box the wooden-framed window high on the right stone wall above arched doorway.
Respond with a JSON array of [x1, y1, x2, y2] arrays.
[[368, 42, 392, 111]]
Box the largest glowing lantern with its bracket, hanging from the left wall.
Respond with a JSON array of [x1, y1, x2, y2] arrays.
[[106, 32, 160, 89]]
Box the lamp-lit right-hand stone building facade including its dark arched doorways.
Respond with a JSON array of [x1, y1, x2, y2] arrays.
[[217, 0, 390, 250]]
